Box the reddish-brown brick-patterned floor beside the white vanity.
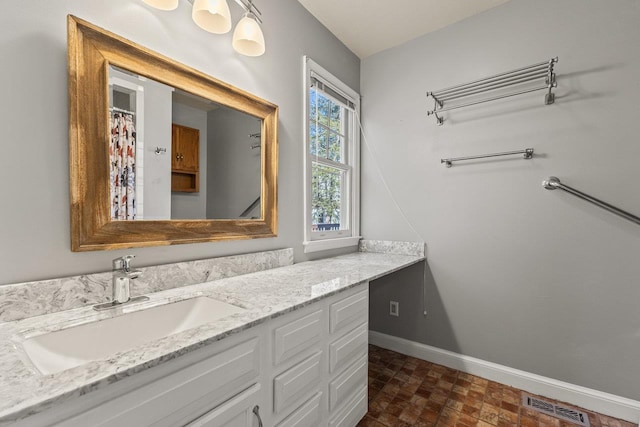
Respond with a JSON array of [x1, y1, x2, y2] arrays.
[[358, 346, 638, 427]]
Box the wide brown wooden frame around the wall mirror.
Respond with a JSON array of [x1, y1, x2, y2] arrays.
[[67, 15, 278, 252]]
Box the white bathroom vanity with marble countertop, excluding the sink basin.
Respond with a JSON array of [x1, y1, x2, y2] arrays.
[[0, 242, 424, 426]]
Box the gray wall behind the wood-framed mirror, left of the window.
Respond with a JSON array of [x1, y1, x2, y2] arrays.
[[0, 0, 360, 284]]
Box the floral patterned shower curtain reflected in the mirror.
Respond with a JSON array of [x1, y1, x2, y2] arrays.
[[109, 111, 136, 220]]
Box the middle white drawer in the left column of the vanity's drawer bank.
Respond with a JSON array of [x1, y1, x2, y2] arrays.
[[273, 351, 322, 412]]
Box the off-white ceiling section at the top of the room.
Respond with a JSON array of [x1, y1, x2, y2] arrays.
[[298, 0, 509, 58]]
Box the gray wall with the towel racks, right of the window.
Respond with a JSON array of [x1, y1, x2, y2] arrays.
[[361, 0, 640, 399]]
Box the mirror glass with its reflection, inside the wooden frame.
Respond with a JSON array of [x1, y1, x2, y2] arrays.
[[108, 66, 262, 224]]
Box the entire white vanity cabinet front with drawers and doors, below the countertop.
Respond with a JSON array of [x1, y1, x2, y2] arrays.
[[18, 283, 369, 427]]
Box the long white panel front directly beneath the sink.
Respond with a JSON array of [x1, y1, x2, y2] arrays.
[[62, 338, 260, 427]]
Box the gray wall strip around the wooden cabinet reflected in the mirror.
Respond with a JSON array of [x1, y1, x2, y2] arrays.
[[171, 102, 208, 219]]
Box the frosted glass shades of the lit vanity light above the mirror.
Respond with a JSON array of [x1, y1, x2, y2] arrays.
[[142, 0, 265, 56]]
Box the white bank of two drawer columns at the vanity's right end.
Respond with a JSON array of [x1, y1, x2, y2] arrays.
[[268, 284, 369, 427]]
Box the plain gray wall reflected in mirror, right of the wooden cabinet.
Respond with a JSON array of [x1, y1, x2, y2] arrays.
[[207, 108, 261, 218]]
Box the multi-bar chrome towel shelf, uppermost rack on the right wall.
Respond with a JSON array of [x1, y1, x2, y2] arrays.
[[427, 57, 558, 125]]
